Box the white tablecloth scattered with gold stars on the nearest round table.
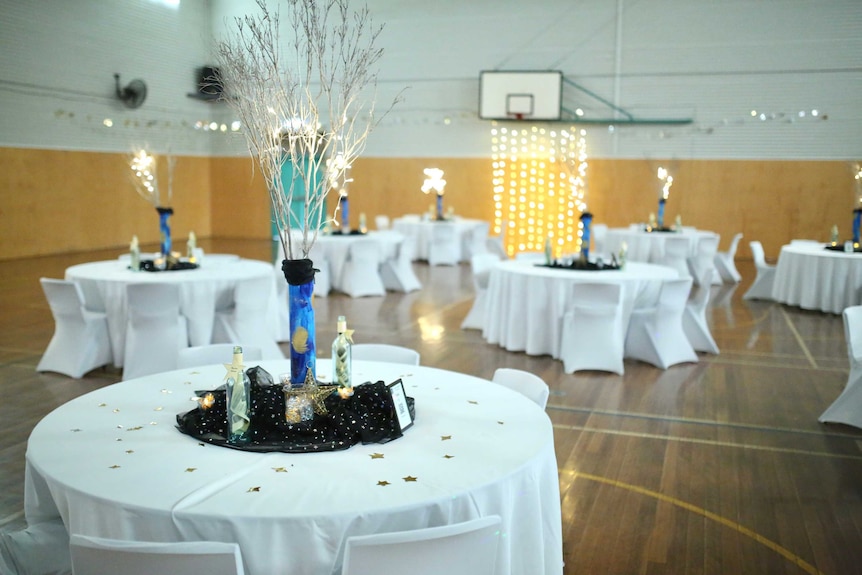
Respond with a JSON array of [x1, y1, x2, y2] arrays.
[[25, 360, 563, 575]]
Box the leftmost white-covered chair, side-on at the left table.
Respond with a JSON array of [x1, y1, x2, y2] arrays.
[[36, 278, 114, 379]]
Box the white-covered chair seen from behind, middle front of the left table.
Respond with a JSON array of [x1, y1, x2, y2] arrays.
[[123, 283, 189, 380]]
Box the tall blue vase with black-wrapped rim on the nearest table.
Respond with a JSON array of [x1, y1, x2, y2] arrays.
[[281, 259, 317, 387]]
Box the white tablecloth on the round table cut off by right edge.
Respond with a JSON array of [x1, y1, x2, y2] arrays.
[[772, 243, 862, 314]]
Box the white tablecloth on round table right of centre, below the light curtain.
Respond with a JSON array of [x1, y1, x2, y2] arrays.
[[482, 260, 678, 358]]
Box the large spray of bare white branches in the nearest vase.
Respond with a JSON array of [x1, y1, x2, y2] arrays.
[[216, 0, 398, 260]]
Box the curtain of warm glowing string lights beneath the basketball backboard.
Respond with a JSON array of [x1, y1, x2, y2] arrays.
[[491, 123, 587, 257]]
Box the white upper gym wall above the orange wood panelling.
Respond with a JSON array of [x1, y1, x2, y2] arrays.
[[0, 0, 862, 159]]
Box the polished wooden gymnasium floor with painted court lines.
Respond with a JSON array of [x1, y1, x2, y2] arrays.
[[0, 240, 862, 575]]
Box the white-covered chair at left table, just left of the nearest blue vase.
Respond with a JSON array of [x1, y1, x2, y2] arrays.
[[212, 276, 284, 359]]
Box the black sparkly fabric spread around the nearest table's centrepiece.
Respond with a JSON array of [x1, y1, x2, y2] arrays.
[[177, 367, 415, 453]]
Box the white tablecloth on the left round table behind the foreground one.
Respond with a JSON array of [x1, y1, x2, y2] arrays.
[[66, 257, 277, 367]]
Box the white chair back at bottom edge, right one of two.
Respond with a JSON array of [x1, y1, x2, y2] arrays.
[[341, 515, 503, 575]]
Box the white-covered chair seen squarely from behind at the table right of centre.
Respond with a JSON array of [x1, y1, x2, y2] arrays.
[[560, 283, 625, 375]]
